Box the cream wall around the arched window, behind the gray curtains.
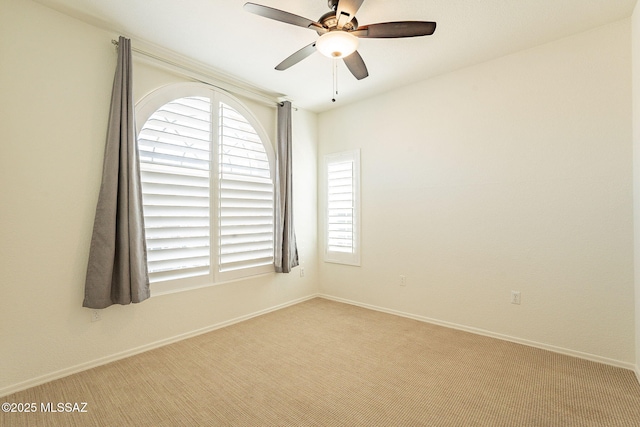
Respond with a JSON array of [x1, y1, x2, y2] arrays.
[[0, 0, 317, 395]]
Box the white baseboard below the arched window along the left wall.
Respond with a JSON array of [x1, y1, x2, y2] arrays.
[[0, 294, 319, 397]]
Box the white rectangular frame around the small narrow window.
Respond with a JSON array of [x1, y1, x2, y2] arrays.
[[322, 149, 362, 266]]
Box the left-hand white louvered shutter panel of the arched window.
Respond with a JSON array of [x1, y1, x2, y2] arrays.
[[138, 97, 211, 282]]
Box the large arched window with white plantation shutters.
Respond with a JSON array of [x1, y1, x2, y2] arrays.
[[136, 84, 274, 287]]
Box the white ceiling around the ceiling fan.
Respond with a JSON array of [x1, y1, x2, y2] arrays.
[[36, 0, 637, 112]]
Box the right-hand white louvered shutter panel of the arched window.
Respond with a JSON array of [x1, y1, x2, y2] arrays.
[[218, 103, 274, 272]]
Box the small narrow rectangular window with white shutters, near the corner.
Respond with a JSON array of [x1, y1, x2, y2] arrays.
[[324, 150, 360, 265]]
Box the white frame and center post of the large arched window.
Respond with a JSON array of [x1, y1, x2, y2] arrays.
[[135, 82, 276, 296]]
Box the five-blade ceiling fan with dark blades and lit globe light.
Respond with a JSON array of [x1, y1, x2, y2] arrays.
[[244, 0, 436, 80]]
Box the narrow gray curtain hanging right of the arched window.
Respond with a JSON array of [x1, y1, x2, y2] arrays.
[[273, 101, 298, 273]]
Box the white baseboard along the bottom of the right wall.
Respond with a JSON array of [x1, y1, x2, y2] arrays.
[[318, 294, 640, 374]]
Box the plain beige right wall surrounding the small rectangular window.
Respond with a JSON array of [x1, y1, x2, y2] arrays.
[[318, 19, 635, 367]]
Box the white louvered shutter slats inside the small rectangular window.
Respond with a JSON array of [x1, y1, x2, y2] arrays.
[[327, 160, 355, 253]]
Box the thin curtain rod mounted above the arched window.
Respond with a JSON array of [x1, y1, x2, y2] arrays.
[[111, 39, 298, 111]]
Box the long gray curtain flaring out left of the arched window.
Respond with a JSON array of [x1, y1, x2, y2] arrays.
[[82, 37, 150, 308]]
